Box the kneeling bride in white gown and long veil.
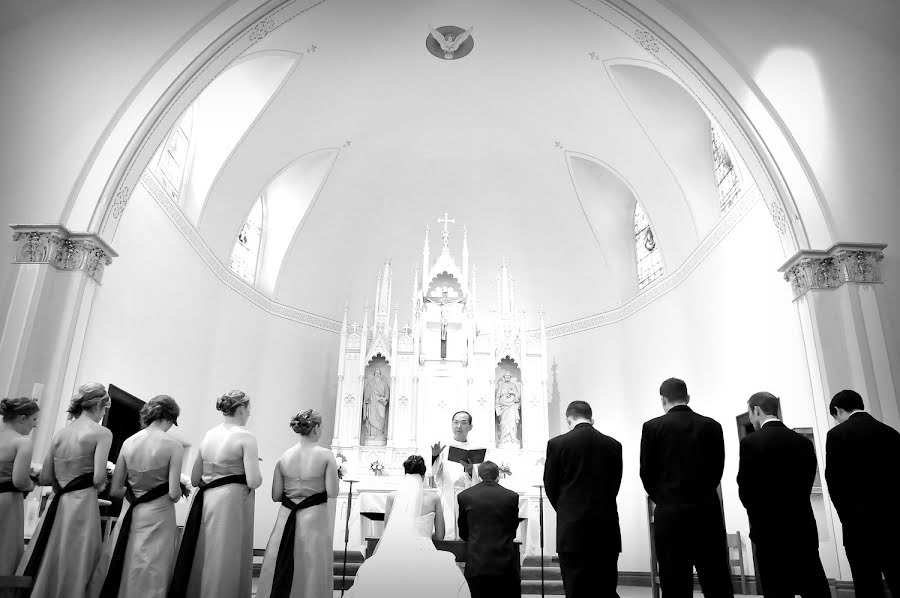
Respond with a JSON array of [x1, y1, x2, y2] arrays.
[[349, 455, 471, 598]]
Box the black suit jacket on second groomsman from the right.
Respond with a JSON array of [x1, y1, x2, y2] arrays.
[[738, 421, 819, 549]]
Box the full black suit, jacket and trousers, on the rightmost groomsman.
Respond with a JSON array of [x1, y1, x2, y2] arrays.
[[825, 412, 900, 598]]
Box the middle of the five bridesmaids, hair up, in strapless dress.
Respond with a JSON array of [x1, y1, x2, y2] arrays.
[[88, 395, 184, 598]]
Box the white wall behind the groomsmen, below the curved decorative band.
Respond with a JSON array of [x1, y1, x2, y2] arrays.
[[549, 203, 838, 577]]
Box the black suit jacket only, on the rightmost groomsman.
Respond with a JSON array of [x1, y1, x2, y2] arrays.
[[825, 412, 900, 545]]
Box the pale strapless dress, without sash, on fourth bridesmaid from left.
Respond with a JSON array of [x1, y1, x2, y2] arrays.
[[179, 458, 255, 598]]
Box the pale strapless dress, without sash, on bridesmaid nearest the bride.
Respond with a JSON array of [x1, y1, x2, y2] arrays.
[[256, 476, 334, 598]]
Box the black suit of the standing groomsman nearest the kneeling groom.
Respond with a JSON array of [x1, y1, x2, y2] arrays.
[[544, 422, 622, 598]]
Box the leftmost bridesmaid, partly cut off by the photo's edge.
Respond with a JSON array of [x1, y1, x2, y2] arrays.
[[0, 398, 40, 596]]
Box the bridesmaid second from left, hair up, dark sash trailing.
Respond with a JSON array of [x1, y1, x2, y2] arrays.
[[16, 382, 112, 598]]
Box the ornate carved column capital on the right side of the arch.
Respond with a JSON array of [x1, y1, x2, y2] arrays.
[[778, 243, 887, 300]]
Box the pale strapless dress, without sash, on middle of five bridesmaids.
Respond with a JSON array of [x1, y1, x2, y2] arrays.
[[88, 464, 176, 598]]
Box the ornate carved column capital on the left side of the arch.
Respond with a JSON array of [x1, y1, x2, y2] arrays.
[[10, 224, 119, 283]]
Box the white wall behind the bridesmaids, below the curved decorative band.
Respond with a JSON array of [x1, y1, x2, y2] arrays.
[[78, 188, 339, 547]]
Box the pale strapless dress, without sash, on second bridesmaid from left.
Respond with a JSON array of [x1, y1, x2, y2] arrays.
[[16, 458, 101, 598]]
